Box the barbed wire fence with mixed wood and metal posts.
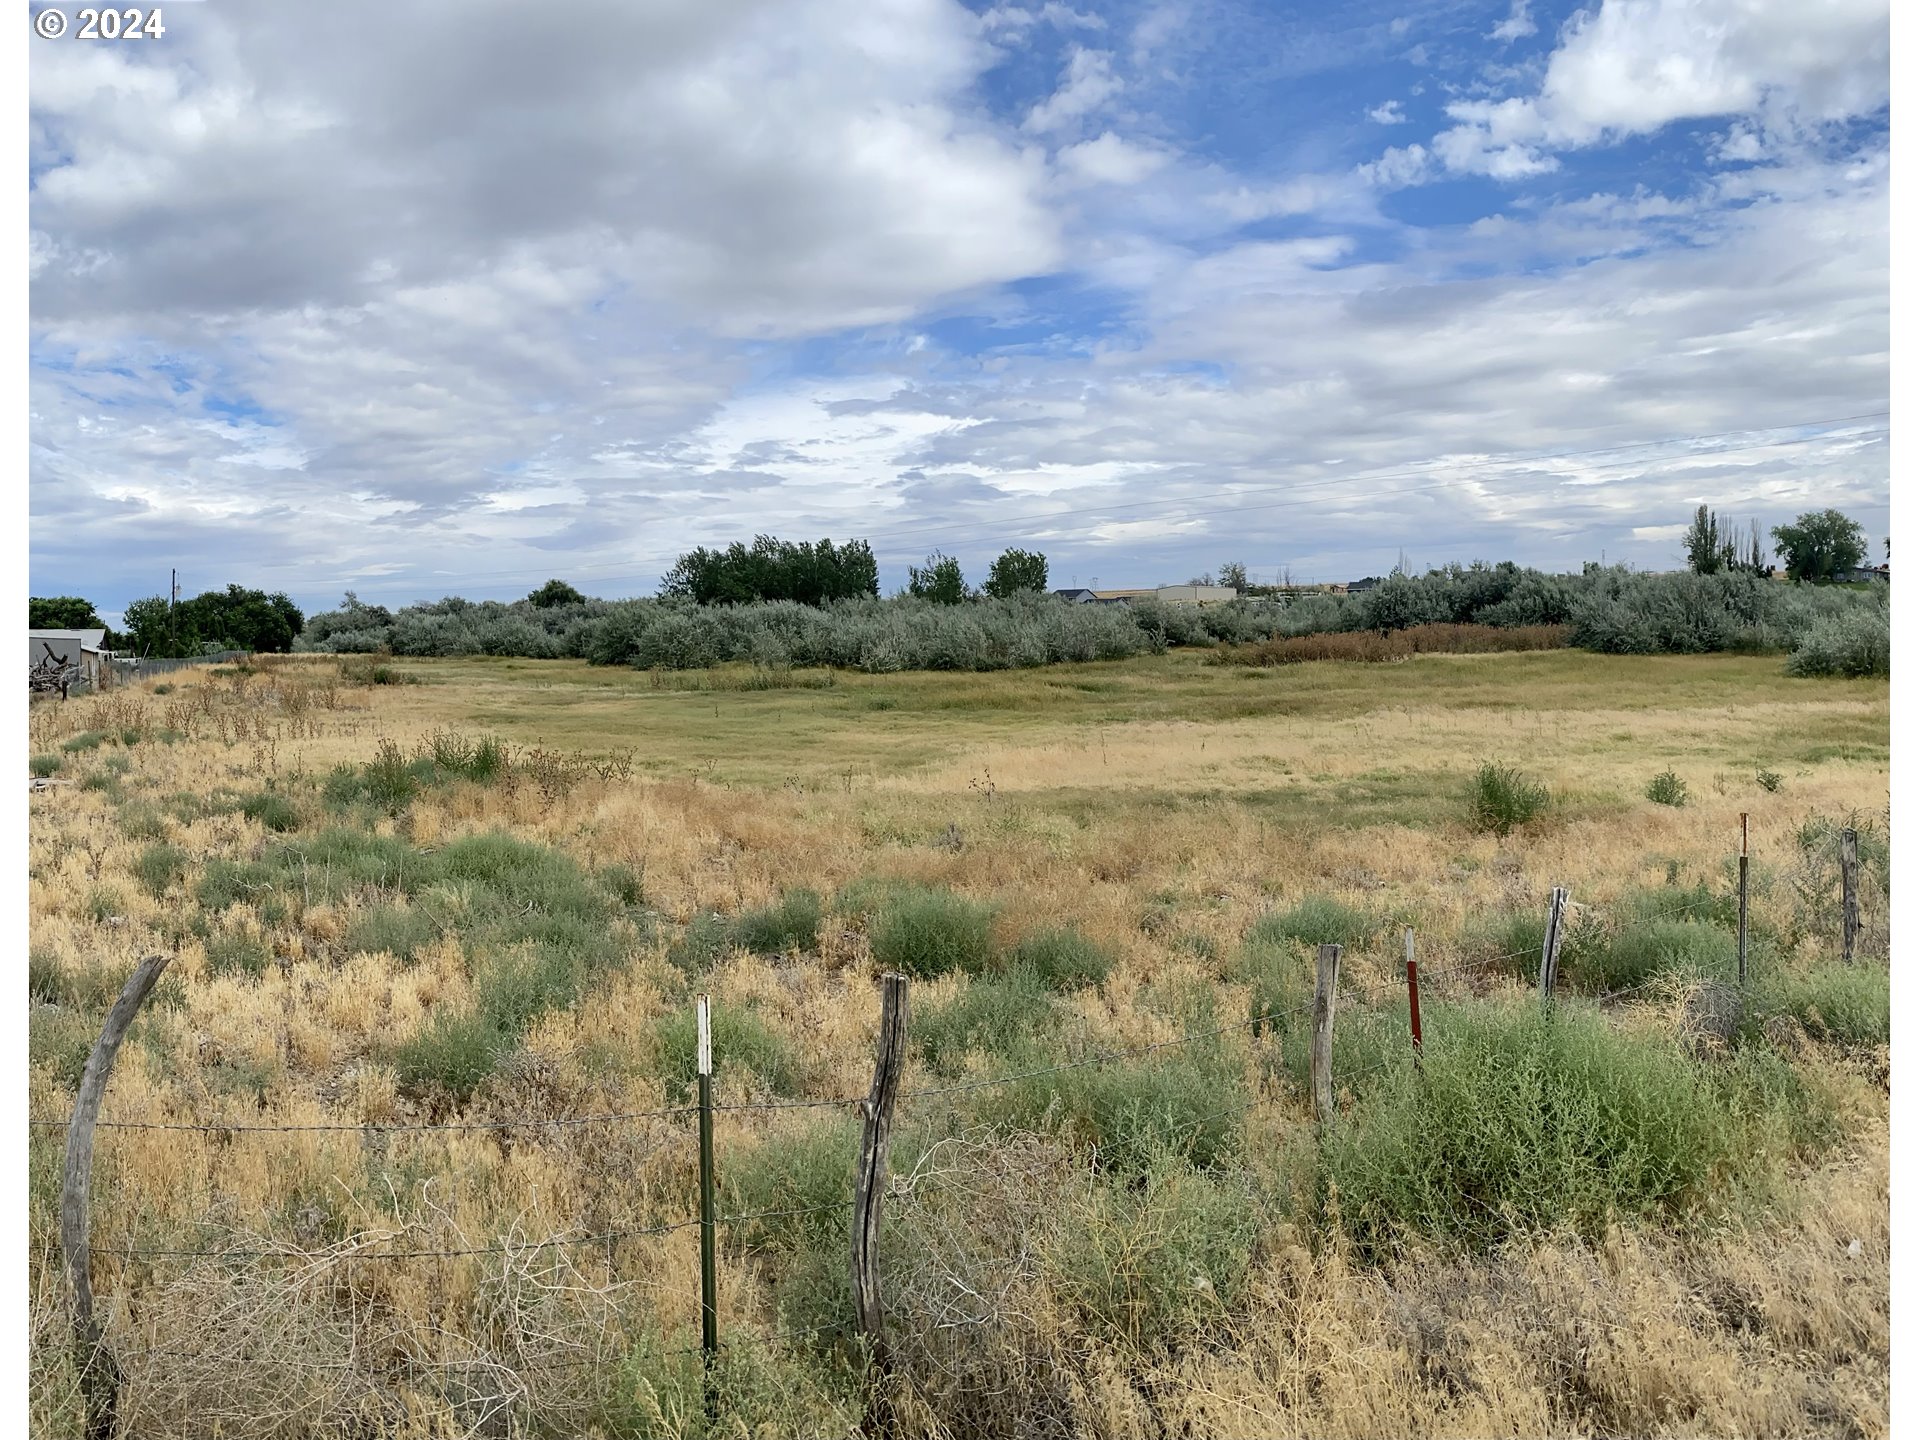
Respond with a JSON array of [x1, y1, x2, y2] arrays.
[[29, 816, 1859, 1440]]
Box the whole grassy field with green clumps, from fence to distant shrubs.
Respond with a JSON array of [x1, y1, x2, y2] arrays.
[[29, 651, 1889, 1440]]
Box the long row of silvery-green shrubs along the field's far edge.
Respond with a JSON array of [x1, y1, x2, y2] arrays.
[[296, 563, 1889, 674]]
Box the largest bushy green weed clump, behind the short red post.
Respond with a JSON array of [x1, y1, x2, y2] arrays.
[[1323, 1002, 1822, 1258]]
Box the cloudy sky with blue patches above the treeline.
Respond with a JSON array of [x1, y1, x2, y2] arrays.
[[29, 0, 1889, 612]]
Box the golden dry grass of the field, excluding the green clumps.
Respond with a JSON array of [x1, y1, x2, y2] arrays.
[[29, 659, 1887, 1436]]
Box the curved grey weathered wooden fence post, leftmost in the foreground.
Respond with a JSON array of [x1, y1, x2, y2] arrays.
[[60, 954, 173, 1440]]
